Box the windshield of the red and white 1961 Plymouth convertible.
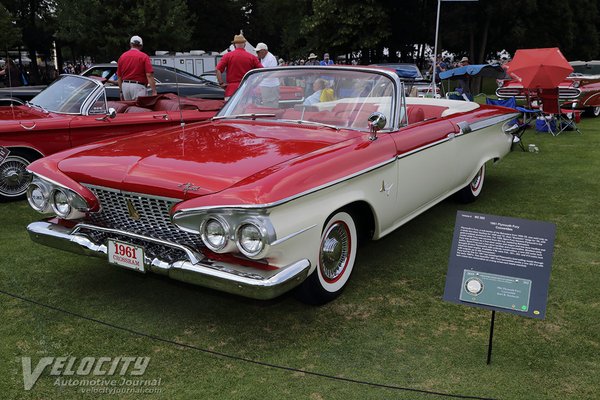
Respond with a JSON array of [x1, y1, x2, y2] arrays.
[[217, 67, 396, 131]]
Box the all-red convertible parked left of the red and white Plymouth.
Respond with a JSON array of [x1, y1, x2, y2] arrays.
[[0, 75, 223, 201]]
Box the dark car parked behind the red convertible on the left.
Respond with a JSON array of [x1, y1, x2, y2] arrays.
[[0, 63, 225, 101]]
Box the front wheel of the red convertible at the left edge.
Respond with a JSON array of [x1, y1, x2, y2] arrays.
[[0, 150, 34, 202]]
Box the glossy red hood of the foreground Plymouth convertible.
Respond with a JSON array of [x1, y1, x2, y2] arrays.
[[58, 121, 360, 199]]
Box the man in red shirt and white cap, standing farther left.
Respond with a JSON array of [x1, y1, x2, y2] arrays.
[[117, 36, 156, 100]]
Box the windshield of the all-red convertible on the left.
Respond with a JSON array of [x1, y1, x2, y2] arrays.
[[30, 75, 101, 114]]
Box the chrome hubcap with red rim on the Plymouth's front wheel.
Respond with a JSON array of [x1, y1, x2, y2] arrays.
[[320, 222, 350, 281]]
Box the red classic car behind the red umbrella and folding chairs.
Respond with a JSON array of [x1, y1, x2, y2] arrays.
[[496, 61, 600, 117]]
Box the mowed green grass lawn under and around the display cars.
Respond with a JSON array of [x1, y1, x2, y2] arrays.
[[0, 119, 600, 399]]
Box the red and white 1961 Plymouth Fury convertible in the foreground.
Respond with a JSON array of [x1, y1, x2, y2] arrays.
[[28, 66, 517, 304]]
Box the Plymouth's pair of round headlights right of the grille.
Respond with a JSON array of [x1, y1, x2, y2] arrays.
[[200, 216, 267, 259]]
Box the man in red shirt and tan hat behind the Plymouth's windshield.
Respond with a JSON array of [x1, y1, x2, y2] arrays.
[[216, 34, 263, 100]]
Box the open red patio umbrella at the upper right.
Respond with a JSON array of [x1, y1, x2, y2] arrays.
[[507, 47, 573, 89]]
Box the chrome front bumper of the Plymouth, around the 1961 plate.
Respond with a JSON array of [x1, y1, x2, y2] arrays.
[[27, 221, 310, 300]]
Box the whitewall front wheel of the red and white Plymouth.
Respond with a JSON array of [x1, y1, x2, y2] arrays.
[[296, 211, 358, 305]]
